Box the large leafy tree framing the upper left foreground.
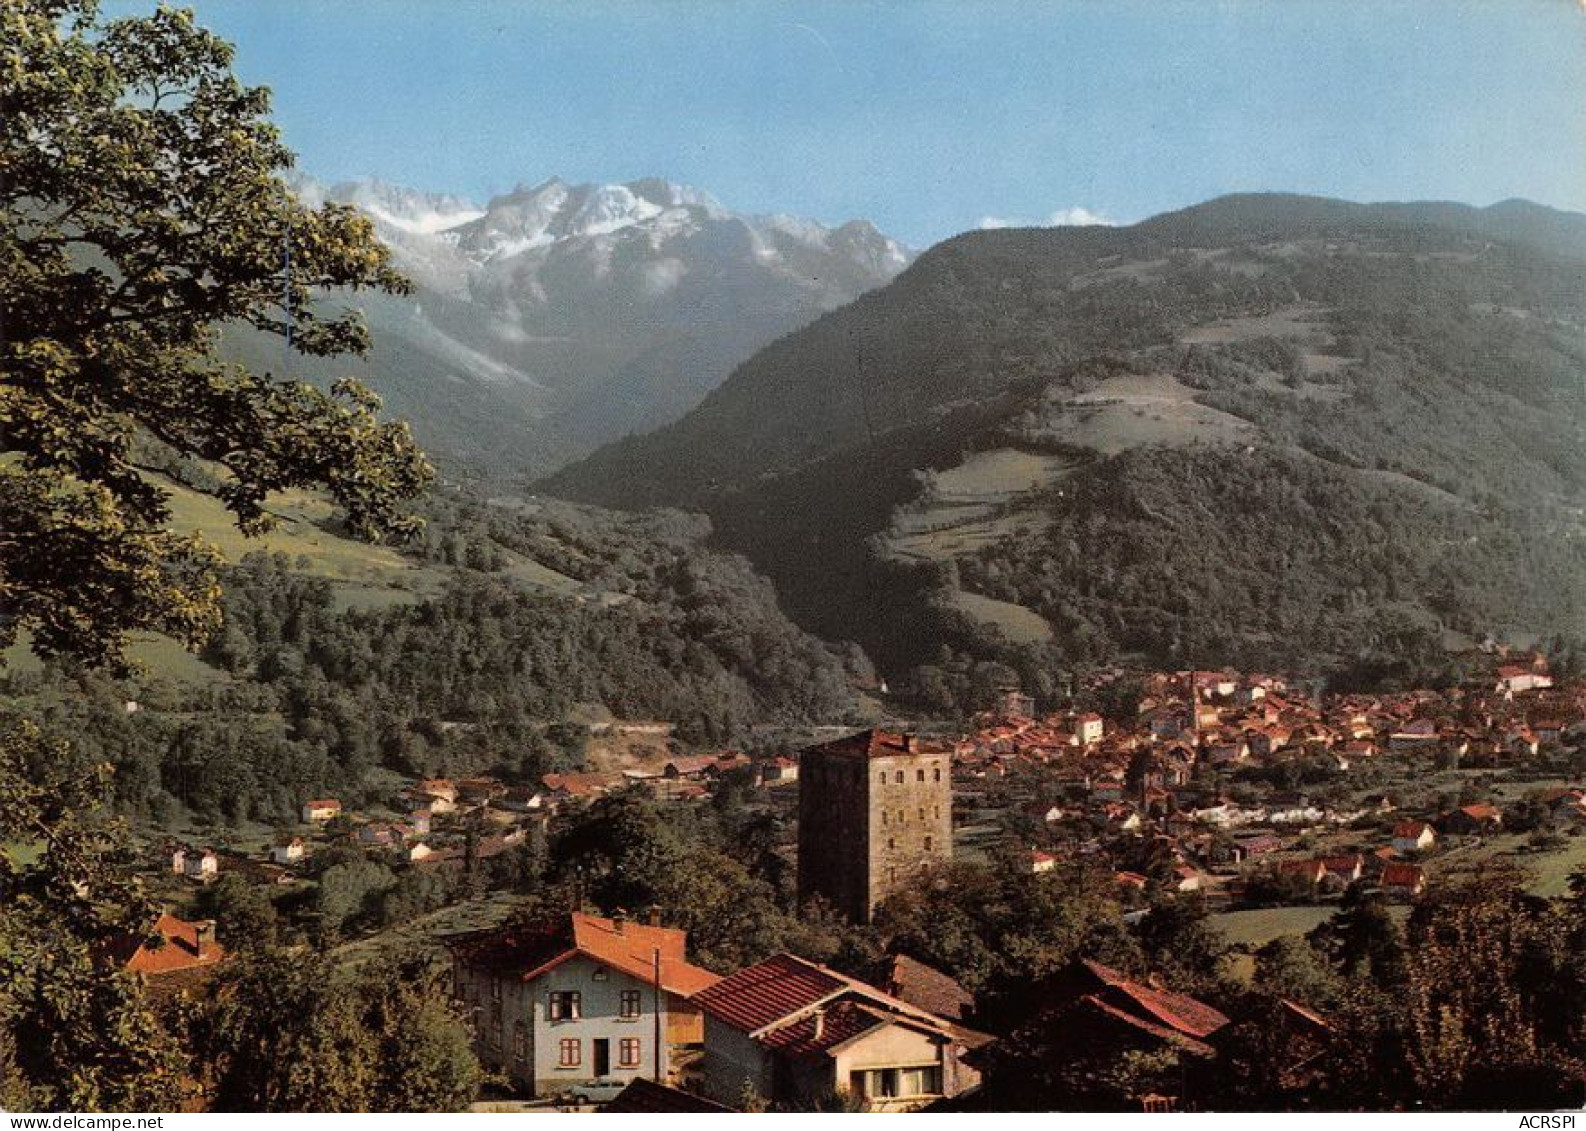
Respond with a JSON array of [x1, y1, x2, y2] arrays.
[[0, 0, 430, 665]]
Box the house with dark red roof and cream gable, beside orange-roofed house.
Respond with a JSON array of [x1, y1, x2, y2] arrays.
[[695, 955, 990, 1112]]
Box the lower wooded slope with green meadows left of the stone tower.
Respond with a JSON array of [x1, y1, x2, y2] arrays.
[[0, 489, 864, 825]]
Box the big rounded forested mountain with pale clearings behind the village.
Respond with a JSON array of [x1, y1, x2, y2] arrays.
[[546, 195, 1586, 691]]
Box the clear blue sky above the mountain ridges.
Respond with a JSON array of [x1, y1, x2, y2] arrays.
[[109, 0, 1586, 246]]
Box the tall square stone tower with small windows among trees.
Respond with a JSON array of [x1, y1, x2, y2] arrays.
[[798, 730, 953, 923]]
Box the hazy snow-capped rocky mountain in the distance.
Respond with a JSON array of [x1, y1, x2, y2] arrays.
[[252, 178, 912, 477]]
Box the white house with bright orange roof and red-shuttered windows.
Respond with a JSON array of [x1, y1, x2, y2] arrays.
[[449, 912, 718, 1096]]
